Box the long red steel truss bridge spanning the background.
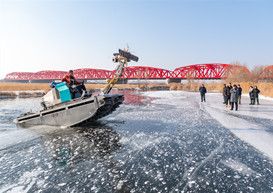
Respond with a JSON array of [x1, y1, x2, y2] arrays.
[[4, 63, 258, 81]]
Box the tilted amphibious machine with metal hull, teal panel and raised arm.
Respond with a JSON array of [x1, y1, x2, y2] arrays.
[[16, 49, 138, 127]]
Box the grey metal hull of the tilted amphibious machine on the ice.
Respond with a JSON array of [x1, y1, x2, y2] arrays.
[[16, 94, 124, 127]]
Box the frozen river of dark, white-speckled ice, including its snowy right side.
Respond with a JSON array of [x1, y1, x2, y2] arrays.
[[0, 91, 273, 193]]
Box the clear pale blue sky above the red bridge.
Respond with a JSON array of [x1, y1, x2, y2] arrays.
[[0, 0, 273, 79]]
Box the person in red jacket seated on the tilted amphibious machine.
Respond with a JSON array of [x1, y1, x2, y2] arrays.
[[62, 70, 86, 98]]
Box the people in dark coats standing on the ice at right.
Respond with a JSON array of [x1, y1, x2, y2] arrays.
[[199, 83, 260, 111]]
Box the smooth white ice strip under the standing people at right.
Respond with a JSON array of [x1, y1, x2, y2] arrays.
[[203, 94, 273, 159]]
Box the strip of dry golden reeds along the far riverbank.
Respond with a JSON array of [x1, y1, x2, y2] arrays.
[[0, 81, 273, 98]]
